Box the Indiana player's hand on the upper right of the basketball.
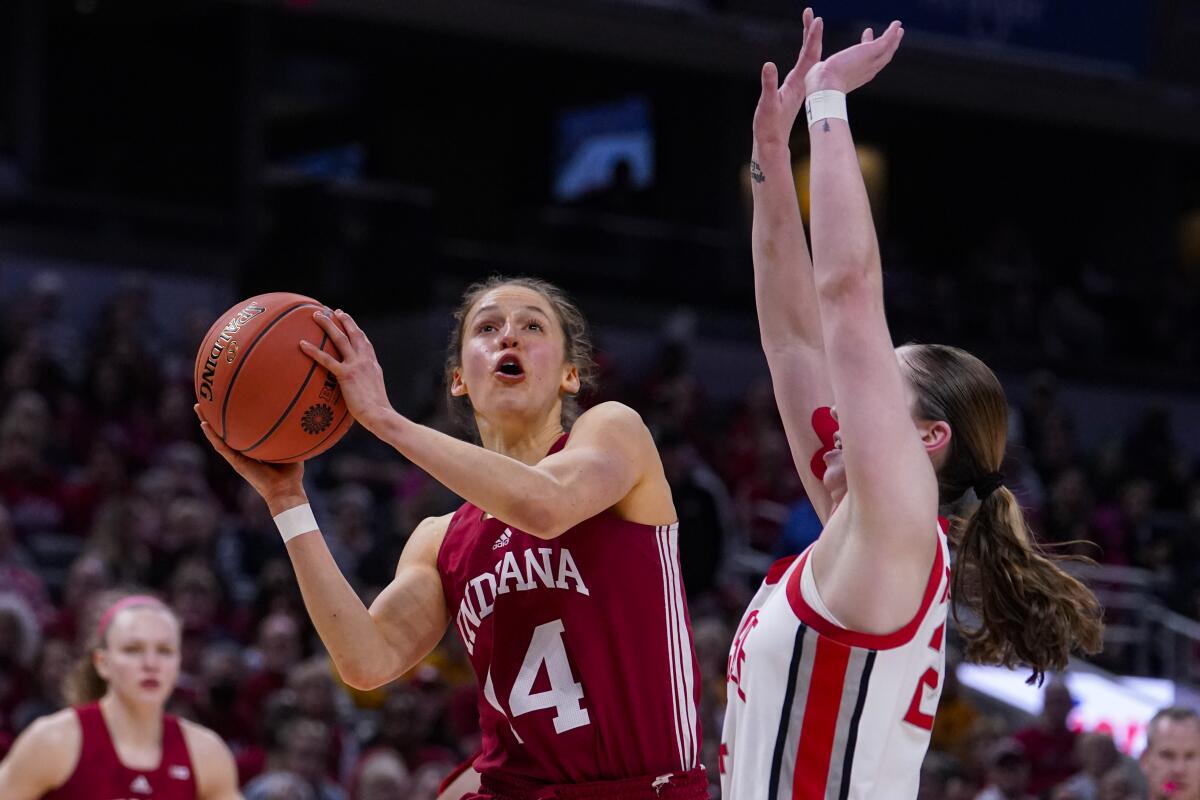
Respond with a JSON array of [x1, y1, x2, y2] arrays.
[[300, 308, 391, 431]]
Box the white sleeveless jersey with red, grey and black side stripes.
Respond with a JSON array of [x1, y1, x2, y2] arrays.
[[720, 530, 950, 800]]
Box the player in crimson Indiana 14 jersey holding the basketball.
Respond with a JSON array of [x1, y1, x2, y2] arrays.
[[196, 278, 707, 800]]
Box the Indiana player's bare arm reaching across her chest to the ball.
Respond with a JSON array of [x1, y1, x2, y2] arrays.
[[301, 311, 674, 539]]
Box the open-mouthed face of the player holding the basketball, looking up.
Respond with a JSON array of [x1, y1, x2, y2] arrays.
[[450, 285, 580, 423]]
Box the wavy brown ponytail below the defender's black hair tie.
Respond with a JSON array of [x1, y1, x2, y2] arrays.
[[953, 487, 1103, 685]]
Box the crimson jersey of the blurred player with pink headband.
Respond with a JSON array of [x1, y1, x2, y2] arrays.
[[43, 703, 197, 800]]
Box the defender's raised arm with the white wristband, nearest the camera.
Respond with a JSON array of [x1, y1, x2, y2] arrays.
[[805, 23, 937, 542]]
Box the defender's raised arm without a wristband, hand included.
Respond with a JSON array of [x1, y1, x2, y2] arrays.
[[750, 8, 833, 523]]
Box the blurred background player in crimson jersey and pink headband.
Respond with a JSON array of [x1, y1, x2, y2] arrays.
[[0, 595, 241, 800]]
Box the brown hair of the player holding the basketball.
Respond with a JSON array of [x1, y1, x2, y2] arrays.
[[445, 275, 595, 432]]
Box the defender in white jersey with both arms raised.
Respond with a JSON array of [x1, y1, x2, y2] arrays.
[[721, 11, 1100, 800]]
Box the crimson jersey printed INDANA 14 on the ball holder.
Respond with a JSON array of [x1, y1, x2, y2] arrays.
[[438, 437, 700, 786]]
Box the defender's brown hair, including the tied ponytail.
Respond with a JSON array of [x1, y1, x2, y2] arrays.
[[900, 344, 1103, 684]]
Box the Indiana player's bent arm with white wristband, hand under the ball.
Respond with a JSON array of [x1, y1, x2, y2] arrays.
[[202, 422, 450, 690]]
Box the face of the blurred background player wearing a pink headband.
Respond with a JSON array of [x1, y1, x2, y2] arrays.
[[95, 608, 180, 706]]
